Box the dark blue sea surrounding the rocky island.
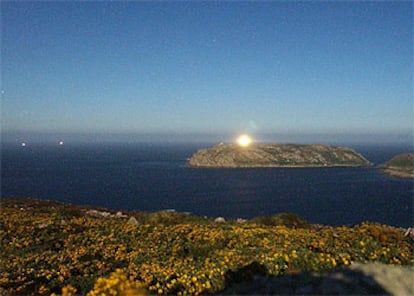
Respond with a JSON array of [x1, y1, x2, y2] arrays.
[[1, 144, 414, 227]]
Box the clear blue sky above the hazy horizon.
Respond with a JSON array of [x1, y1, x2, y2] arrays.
[[1, 1, 414, 142]]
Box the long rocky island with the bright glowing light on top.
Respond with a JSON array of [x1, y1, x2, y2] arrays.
[[188, 144, 370, 168]]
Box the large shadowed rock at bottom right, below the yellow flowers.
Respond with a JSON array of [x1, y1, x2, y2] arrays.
[[222, 263, 414, 295]]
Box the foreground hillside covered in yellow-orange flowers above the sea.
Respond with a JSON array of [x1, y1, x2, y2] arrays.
[[0, 199, 414, 295]]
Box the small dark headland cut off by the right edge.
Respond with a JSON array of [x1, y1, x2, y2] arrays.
[[380, 153, 414, 179]]
